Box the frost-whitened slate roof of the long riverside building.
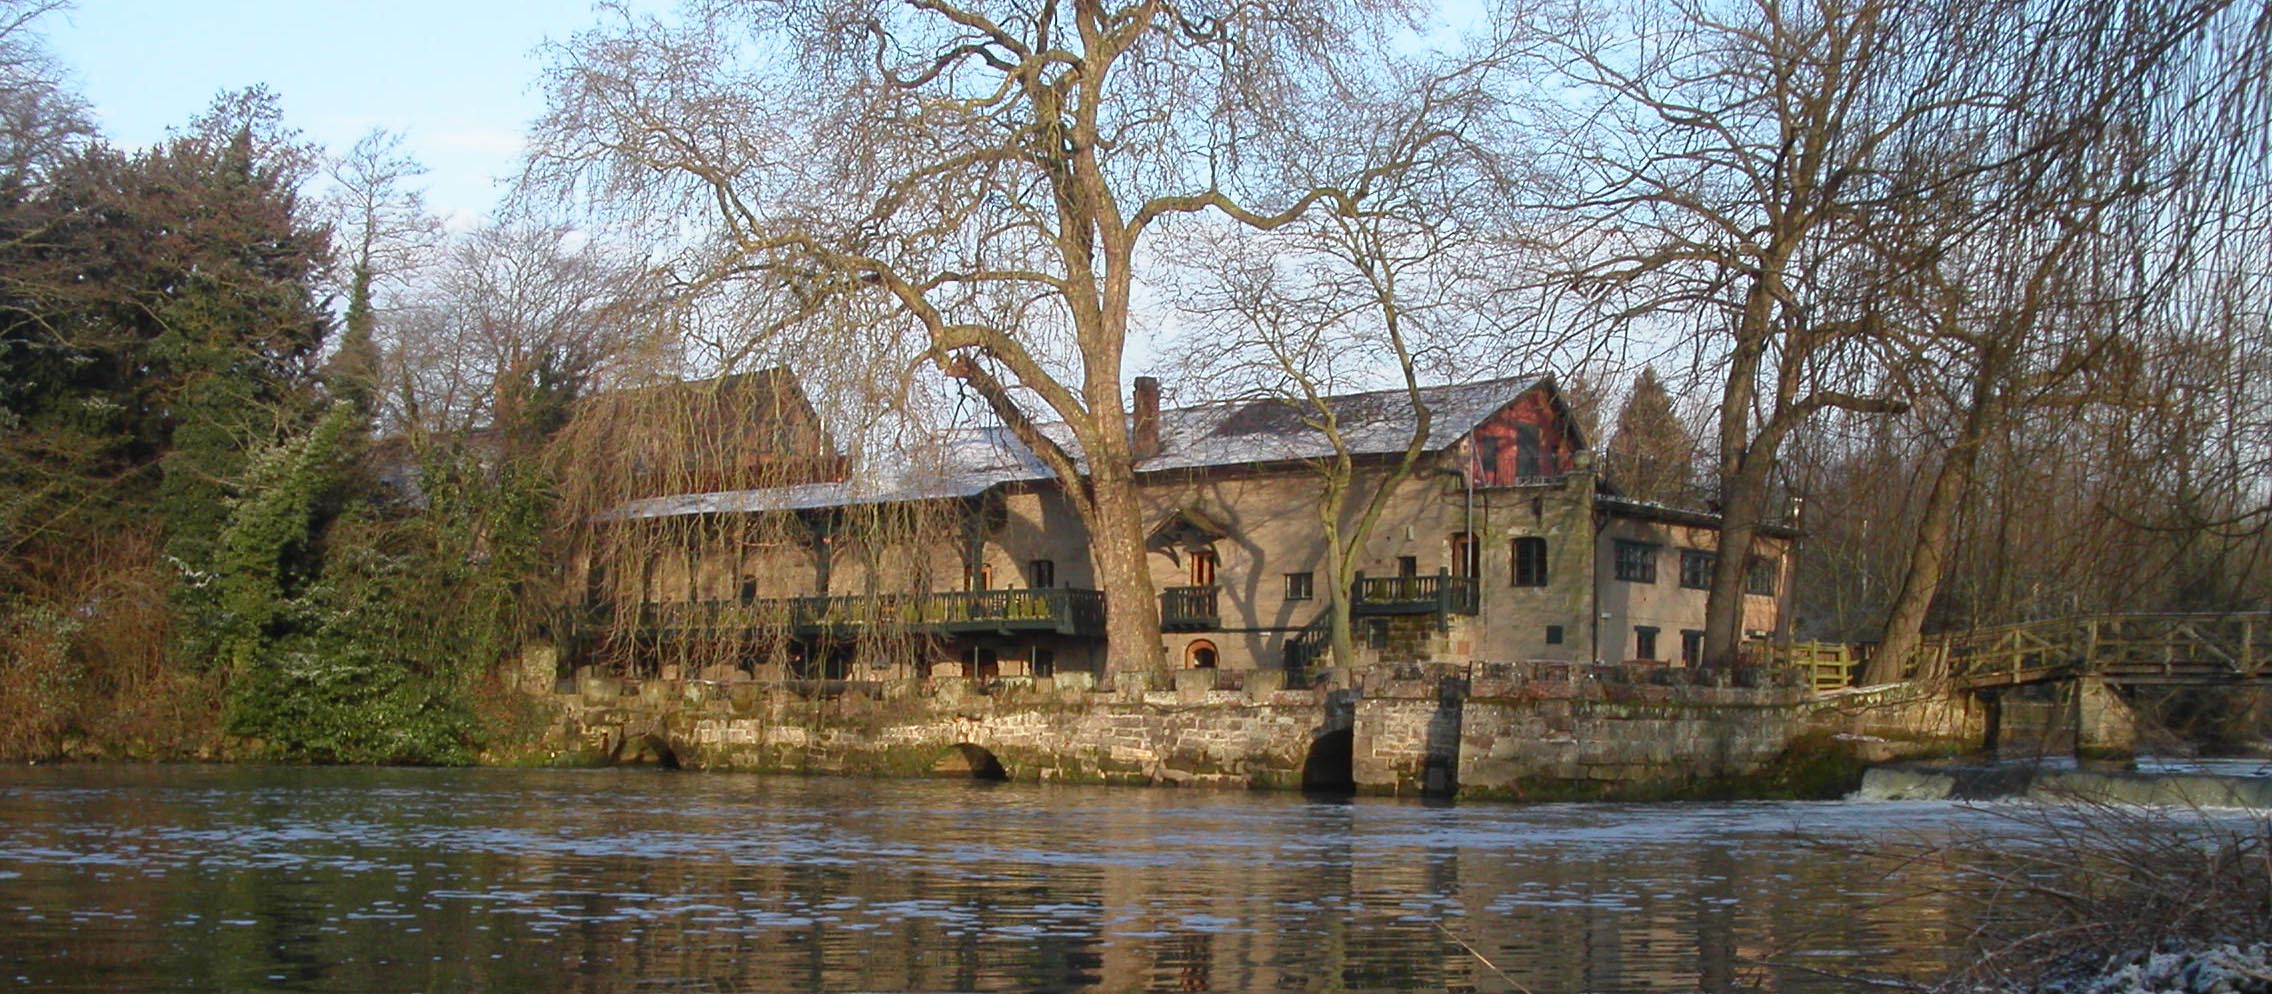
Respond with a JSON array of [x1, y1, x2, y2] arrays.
[[609, 377, 1550, 517]]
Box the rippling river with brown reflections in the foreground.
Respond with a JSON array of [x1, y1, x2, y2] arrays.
[[0, 765, 2144, 994]]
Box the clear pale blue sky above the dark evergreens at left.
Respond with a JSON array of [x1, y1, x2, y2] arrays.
[[39, 0, 658, 225]]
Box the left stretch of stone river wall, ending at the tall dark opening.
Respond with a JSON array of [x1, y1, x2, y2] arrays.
[[531, 672, 1347, 790]]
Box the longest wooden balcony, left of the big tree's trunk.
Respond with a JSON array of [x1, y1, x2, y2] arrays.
[[638, 588, 1104, 638]]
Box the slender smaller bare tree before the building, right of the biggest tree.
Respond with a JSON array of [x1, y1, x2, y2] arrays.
[[1172, 64, 1552, 667]]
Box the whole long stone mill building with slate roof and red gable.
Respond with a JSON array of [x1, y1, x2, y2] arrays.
[[573, 370, 1795, 681]]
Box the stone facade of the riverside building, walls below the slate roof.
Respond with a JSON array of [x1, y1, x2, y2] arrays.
[[579, 381, 1790, 681]]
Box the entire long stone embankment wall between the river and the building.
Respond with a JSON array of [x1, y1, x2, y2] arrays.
[[529, 663, 1983, 799]]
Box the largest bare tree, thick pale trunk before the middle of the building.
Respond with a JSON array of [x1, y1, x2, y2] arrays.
[[529, 0, 1499, 669]]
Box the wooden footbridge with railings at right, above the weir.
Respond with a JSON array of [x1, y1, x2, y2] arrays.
[[1781, 610, 2272, 690]]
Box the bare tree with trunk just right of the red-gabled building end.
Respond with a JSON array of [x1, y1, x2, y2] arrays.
[[1508, 0, 1986, 665]]
